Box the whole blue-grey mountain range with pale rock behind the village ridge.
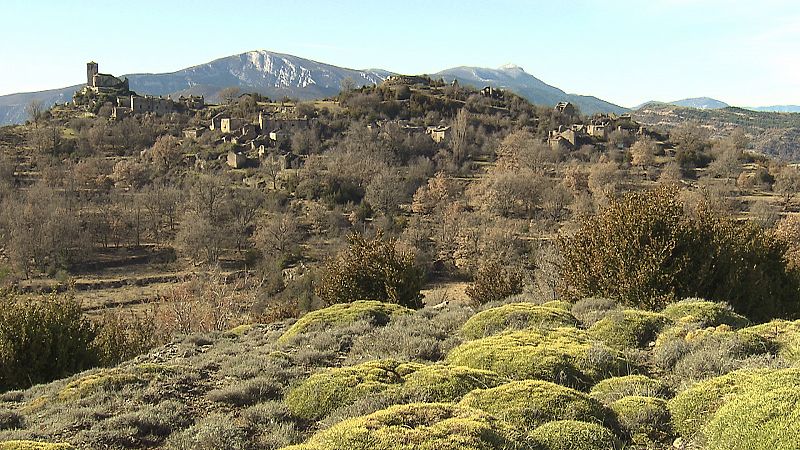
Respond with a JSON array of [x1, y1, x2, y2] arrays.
[[0, 50, 627, 125]]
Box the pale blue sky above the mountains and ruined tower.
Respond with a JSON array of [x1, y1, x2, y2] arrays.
[[0, 0, 800, 107]]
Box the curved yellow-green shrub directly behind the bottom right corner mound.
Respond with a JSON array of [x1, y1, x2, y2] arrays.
[[669, 369, 800, 439]]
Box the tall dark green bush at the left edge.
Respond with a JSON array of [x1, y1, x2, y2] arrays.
[[0, 293, 99, 391]]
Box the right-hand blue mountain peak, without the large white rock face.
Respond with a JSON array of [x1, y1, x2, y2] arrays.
[[431, 64, 628, 114]]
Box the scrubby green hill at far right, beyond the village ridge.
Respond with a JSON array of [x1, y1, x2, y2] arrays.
[[632, 102, 800, 161]]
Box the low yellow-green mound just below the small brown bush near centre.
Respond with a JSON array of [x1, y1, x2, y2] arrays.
[[461, 303, 578, 339]]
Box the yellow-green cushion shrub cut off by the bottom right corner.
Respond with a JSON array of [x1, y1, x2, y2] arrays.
[[705, 380, 800, 450]]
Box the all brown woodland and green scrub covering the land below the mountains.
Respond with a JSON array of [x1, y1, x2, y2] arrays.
[[0, 73, 800, 450]]
